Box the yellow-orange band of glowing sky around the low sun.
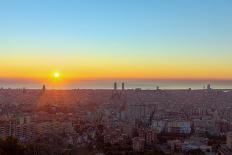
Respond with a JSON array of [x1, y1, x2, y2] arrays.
[[0, 49, 232, 83]]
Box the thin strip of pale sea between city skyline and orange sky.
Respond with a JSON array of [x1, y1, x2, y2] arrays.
[[0, 79, 232, 90]]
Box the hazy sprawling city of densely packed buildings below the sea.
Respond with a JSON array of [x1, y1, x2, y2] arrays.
[[0, 82, 232, 155]]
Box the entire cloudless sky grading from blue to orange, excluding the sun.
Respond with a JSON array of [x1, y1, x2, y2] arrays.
[[0, 0, 232, 79]]
